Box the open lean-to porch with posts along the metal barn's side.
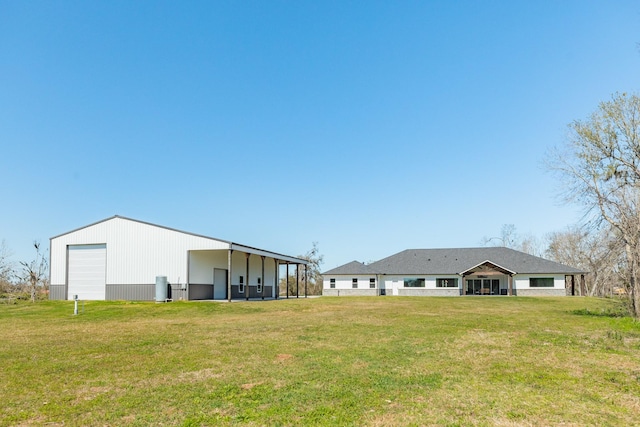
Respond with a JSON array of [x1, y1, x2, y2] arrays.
[[180, 244, 307, 301]]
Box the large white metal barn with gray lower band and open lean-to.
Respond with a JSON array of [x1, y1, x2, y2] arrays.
[[49, 215, 307, 301]]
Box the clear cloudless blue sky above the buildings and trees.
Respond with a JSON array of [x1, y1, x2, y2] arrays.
[[0, 0, 640, 269]]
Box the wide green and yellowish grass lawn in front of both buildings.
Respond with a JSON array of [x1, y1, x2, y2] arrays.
[[0, 297, 640, 426]]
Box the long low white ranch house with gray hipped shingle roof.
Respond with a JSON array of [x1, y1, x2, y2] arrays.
[[322, 247, 586, 296]]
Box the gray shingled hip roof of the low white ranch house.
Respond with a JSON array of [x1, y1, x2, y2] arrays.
[[323, 247, 585, 275]]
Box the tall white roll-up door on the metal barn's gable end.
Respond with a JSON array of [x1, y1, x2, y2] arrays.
[[68, 245, 107, 300]]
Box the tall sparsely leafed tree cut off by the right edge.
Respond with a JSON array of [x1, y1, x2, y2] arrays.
[[549, 93, 640, 317]]
